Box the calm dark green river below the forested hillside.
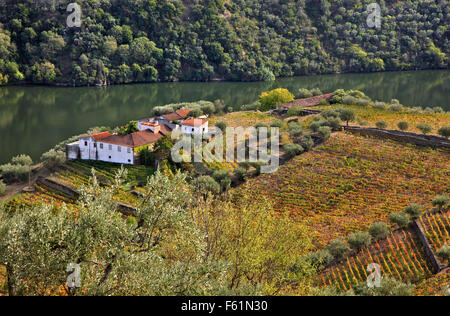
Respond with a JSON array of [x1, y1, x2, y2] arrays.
[[0, 70, 450, 163]]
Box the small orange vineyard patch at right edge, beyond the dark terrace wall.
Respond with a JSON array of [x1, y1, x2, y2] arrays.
[[419, 212, 450, 252]]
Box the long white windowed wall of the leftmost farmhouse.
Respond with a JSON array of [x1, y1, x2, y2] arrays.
[[80, 137, 134, 165]]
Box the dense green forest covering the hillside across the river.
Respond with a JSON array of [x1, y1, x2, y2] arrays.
[[0, 0, 450, 85]]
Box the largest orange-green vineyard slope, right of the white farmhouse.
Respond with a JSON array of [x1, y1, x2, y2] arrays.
[[245, 133, 450, 247]]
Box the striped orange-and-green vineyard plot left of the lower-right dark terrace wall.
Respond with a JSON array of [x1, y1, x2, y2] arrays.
[[320, 230, 433, 291]]
